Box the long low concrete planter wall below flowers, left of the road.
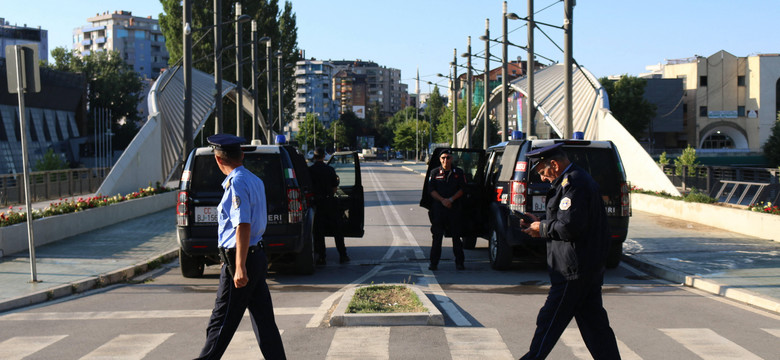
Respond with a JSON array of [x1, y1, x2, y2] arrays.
[[0, 191, 178, 257]]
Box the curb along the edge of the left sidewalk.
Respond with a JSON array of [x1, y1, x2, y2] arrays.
[[0, 247, 179, 312]]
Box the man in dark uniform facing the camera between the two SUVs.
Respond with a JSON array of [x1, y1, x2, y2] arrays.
[[428, 149, 466, 270]]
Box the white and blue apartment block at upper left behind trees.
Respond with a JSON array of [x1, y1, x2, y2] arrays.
[[73, 10, 169, 79]]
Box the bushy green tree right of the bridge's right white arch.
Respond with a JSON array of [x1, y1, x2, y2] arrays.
[[599, 75, 657, 139]]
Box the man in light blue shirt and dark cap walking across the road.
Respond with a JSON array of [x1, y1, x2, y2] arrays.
[[198, 134, 286, 360]]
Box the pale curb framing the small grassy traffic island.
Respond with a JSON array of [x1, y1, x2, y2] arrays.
[[330, 284, 444, 326]]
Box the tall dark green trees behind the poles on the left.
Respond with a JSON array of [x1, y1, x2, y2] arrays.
[[159, 0, 300, 138]]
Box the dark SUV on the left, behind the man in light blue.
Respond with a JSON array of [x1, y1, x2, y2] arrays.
[[176, 145, 363, 277]]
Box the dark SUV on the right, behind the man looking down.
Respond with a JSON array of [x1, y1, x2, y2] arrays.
[[420, 139, 631, 269]]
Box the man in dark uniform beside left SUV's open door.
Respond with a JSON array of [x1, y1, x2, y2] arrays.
[[309, 148, 350, 265]]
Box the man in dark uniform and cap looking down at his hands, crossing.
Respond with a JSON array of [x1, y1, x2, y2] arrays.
[[521, 143, 620, 360]]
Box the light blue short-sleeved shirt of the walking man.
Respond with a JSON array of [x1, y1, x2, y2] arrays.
[[217, 166, 268, 248]]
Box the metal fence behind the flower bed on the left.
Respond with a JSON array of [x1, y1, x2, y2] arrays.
[[0, 167, 111, 206]]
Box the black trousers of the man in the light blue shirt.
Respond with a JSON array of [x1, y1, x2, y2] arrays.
[[198, 249, 286, 360]]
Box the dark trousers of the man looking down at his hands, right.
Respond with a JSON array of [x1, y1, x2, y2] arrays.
[[521, 271, 620, 360]]
